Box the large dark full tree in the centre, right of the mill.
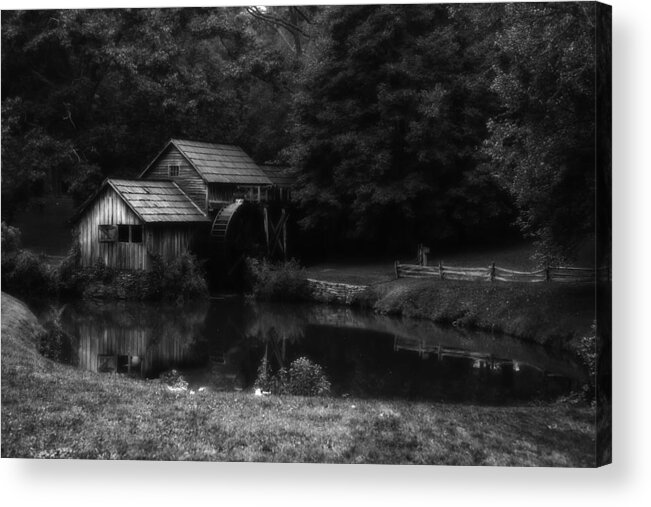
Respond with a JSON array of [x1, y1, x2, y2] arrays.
[[290, 5, 509, 254]]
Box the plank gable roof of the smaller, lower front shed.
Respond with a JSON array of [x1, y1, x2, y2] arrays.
[[73, 178, 208, 223]]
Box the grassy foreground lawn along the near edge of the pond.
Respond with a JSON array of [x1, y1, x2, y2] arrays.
[[2, 294, 595, 467]]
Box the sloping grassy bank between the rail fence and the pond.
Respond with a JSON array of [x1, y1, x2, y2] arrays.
[[370, 279, 595, 349]]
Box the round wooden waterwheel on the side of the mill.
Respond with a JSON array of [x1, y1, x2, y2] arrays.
[[210, 200, 267, 275]]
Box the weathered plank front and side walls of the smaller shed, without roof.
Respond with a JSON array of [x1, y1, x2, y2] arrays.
[[77, 186, 197, 270]]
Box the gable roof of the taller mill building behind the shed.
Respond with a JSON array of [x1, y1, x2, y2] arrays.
[[140, 139, 271, 185]]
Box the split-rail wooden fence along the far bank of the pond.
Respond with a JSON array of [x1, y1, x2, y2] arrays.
[[395, 261, 610, 283]]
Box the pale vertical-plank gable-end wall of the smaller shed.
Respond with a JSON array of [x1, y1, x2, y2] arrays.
[[77, 186, 147, 269]]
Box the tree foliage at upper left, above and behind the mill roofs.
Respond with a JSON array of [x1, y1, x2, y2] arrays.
[[2, 7, 295, 216]]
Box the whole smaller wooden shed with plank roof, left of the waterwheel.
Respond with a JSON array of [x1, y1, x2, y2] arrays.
[[73, 179, 210, 270]]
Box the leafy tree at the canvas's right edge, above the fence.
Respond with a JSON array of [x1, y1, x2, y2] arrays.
[[485, 3, 596, 260]]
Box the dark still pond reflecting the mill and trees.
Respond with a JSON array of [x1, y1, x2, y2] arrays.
[[57, 297, 585, 403]]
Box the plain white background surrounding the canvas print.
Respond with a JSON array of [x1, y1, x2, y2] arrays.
[[0, 0, 651, 507]]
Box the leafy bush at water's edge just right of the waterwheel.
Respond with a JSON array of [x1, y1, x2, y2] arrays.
[[247, 259, 307, 301]]
